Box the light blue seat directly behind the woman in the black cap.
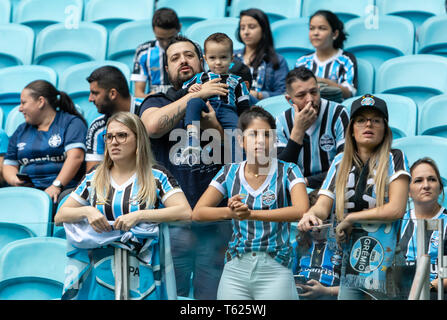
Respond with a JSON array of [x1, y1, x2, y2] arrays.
[[342, 94, 418, 139]]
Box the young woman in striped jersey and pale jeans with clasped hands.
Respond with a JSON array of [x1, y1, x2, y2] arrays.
[[193, 106, 309, 300]]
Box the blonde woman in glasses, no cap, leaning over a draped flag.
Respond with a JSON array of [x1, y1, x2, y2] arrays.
[[55, 112, 191, 300]]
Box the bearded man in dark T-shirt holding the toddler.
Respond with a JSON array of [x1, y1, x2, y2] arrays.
[[140, 36, 231, 299]]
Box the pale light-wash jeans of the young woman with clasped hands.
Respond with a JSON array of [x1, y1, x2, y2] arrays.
[[217, 252, 299, 300]]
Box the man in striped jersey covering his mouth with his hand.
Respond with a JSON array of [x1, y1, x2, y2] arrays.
[[276, 67, 349, 189]]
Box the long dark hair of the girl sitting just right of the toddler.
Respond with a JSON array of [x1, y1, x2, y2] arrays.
[[236, 8, 279, 70]]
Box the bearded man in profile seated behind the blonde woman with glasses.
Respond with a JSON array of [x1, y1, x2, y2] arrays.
[[85, 66, 143, 172]]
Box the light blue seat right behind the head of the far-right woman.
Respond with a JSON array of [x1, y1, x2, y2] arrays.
[[393, 136, 447, 186]]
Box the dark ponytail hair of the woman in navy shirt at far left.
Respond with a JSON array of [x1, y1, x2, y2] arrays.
[[24, 80, 87, 125]]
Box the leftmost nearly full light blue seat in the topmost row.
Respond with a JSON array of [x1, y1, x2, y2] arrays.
[[13, 0, 84, 37]]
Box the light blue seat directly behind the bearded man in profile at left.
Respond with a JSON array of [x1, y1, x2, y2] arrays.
[[59, 60, 130, 125]]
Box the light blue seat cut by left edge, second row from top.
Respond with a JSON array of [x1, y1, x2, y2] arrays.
[[0, 23, 34, 69]]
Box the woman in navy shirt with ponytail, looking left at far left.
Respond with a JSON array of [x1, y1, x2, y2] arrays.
[[3, 80, 87, 202]]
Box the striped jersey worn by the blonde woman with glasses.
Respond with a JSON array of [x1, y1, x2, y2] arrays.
[[71, 165, 182, 221]]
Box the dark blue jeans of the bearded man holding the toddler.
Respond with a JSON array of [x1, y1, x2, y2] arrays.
[[169, 221, 232, 300]]
